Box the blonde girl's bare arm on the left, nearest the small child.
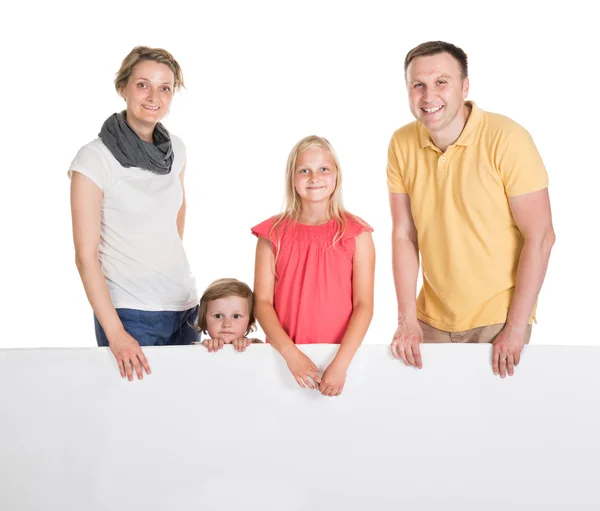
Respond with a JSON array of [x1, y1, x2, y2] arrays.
[[254, 238, 321, 389]]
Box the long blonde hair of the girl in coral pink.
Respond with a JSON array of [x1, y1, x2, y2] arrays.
[[271, 135, 348, 249]]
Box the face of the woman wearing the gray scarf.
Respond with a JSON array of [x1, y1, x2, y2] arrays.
[[121, 60, 175, 131]]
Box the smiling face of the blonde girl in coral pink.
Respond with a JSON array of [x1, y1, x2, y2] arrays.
[[294, 147, 337, 203]]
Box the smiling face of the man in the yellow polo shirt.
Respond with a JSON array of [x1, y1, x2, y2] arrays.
[[406, 52, 469, 133]]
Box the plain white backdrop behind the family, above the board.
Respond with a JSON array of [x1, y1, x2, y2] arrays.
[[0, 1, 600, 347]]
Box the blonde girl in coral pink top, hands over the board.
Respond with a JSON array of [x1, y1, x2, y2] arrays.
[[252, 136, 375, 396]]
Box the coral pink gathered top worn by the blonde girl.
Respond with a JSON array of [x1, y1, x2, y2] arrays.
[[252, 215, 373, 344]]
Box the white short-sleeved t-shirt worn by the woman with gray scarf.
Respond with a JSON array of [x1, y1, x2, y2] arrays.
[[69, 135, 198, 311]]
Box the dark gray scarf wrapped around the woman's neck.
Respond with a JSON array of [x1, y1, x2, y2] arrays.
[[98, 111, 174, 174]]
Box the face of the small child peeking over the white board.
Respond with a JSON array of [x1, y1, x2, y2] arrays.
[[206, 296, 250, 343]]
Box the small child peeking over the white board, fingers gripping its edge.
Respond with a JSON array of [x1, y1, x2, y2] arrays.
[[195, 279, 262, 352]]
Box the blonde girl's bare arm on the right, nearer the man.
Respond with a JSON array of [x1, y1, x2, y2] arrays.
[[320, 232, 375, 396]]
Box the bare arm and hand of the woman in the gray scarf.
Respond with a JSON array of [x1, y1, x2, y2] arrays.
[[71, 171, 150, 380]]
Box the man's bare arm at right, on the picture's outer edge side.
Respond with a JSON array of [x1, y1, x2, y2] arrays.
[[492, 188, 555, 377]]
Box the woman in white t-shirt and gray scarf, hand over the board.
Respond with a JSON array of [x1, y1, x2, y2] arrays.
[[69, 46, 198, 381]]
